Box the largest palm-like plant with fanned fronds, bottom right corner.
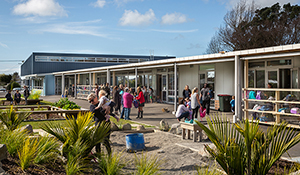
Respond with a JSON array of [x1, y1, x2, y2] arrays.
[[196, 116, 300, 175]]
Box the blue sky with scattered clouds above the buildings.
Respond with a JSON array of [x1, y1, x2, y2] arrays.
[[0, 0, 300, 74]]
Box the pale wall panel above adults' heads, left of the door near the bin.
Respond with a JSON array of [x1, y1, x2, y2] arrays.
[[178, 65, 199, 97]]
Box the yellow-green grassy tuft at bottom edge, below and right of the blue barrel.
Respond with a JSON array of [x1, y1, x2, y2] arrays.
[[134, 153, 165, 175]]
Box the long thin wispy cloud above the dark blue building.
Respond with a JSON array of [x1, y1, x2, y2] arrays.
[[36, 20, 107, 38]]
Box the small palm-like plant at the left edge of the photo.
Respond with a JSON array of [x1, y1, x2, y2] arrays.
[[0, 106, 31, 131]]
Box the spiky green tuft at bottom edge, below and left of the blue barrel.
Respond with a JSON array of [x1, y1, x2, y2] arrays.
[[97, 152, 126, 175]]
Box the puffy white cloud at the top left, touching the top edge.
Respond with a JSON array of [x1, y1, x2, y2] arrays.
[[13, 0, 67, 16]]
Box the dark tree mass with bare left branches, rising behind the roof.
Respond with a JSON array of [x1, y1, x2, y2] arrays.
[[206, 0, 300, 53]]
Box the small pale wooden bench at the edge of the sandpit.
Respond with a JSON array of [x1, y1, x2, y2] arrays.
[[180, 122, 202, 142]]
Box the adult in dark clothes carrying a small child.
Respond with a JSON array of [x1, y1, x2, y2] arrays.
[[88, 93, 111, 154]]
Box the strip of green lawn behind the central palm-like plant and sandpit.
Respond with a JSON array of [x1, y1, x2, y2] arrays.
[[21, 117, 155, 129]]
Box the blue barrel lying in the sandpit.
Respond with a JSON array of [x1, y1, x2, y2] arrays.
[[126, 133, 145, 152]]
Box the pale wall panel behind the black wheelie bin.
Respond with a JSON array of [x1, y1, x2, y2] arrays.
[[215, 62, 235, 100]]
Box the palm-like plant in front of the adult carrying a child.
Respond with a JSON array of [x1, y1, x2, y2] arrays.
[[41, 112, 110, 158]]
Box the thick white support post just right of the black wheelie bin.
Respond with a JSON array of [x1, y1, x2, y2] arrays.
[[233, 55, 242, 123]]
